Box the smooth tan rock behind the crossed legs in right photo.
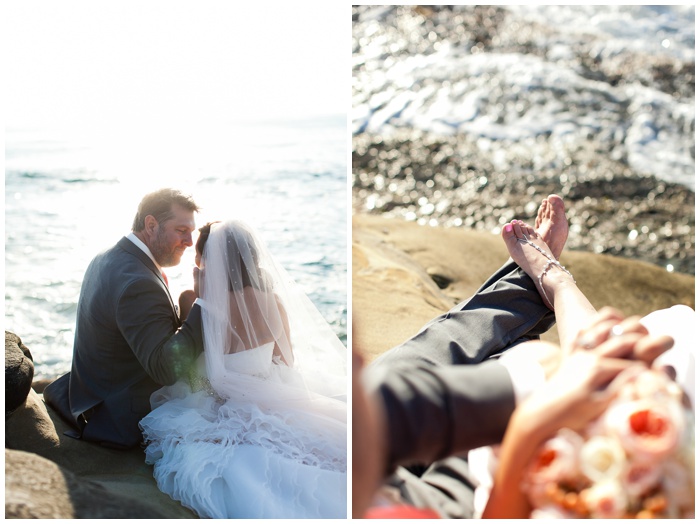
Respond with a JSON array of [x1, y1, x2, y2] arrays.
[[352, 214, 695, 360]]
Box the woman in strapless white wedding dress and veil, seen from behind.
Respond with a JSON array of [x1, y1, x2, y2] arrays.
[[141, 222, 347, 518]]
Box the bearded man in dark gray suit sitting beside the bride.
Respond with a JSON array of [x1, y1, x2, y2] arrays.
[[44, 189, 202, 448]]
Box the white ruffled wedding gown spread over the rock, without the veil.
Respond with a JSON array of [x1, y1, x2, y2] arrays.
[[141, 343, 347, 519]]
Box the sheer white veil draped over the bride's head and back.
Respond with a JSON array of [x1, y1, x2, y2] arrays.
[[199, 221, 347, 406]]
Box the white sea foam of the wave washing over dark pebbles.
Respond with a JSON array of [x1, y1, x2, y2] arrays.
[[352, 6, 695, 190]]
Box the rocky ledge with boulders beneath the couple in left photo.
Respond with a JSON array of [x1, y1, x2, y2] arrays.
[[5, 331, 197, 519]]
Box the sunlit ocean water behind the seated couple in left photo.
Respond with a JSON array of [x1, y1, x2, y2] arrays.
[[5, 116, 348, 378]]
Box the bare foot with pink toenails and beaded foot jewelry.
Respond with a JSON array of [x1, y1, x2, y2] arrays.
[[501, 220, 574, 310]]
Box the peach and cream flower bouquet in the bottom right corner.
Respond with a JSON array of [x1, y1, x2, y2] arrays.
[[523, 370, 695, 518]]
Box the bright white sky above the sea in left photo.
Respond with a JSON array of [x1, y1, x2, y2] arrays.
[[2, 0, 351, 136]]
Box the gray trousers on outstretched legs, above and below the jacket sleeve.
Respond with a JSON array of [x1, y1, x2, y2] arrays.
[[370, 260, 554, 518]]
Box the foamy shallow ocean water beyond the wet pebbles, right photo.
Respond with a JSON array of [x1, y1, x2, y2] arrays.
[[352, 5, 695, 191]]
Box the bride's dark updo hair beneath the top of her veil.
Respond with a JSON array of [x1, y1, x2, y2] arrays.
[[200, 221, 272, 291]]
